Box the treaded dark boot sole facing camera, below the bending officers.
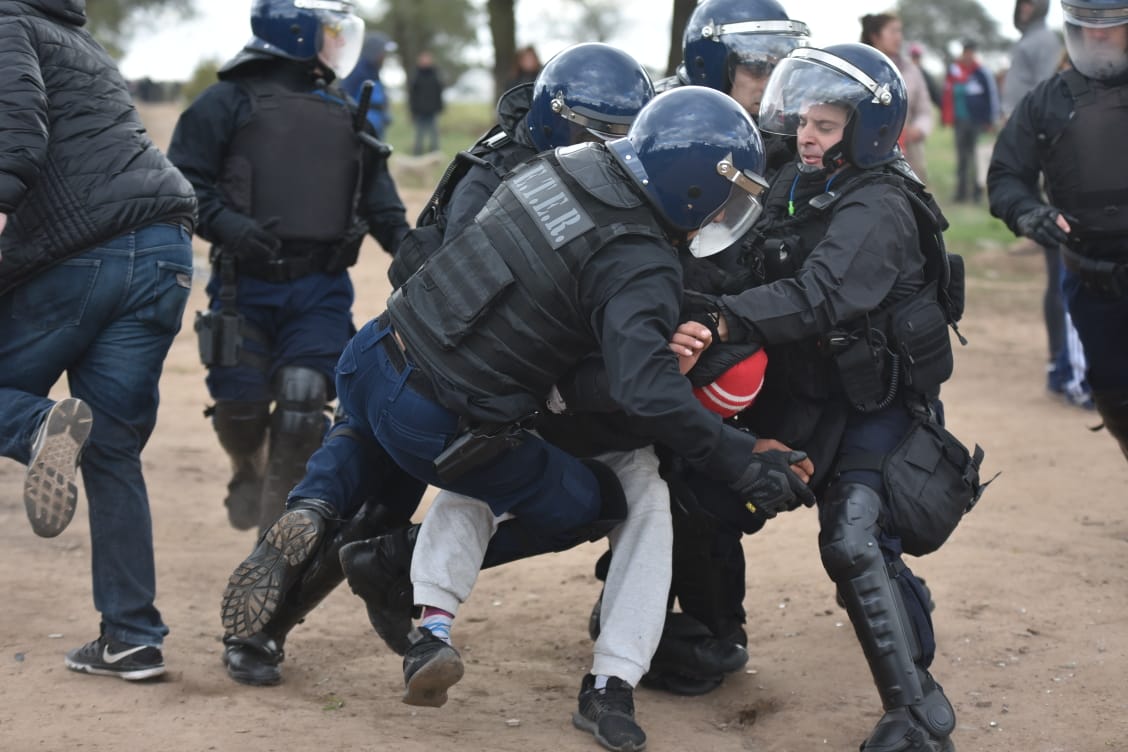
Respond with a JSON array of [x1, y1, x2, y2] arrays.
[[220, 508, 325, 638]]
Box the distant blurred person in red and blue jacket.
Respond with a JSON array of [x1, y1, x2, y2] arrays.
[[941, 39, 998, 203]]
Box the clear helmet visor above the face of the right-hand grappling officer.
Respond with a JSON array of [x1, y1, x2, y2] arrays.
[[759, 50, 870, 135]]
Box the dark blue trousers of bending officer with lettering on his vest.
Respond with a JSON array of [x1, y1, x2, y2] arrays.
[[324, 320, 601, 536]]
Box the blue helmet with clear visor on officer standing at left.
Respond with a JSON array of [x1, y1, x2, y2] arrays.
[[247, 0, 364, 78]]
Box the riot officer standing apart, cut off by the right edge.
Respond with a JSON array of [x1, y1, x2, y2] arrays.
[[987, 0, 1128, 458]]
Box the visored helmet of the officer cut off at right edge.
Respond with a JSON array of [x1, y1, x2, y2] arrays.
[[1061, 0, 1128, 81]]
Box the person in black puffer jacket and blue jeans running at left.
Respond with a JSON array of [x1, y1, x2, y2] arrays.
[[0, 0, 195, 680]]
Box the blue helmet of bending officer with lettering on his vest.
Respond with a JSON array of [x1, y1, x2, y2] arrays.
[[607, 86, 767, 257]]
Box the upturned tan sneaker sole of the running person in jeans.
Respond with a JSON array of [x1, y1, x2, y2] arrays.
[[24, 398, 94, 538]]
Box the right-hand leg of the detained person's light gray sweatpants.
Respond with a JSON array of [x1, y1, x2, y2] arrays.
[[591, 446, 673, 687]]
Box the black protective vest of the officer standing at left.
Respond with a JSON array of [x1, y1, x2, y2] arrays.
[[220, 78, 363, 241]]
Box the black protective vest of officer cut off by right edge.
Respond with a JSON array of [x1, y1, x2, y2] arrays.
[[1039, 71, 1128, 255]]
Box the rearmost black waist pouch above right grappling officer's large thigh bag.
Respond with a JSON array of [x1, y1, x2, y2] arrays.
[[889, 283, 954, 395]]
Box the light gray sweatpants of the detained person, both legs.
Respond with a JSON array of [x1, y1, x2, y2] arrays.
[[412, 448, 673, 687]]
